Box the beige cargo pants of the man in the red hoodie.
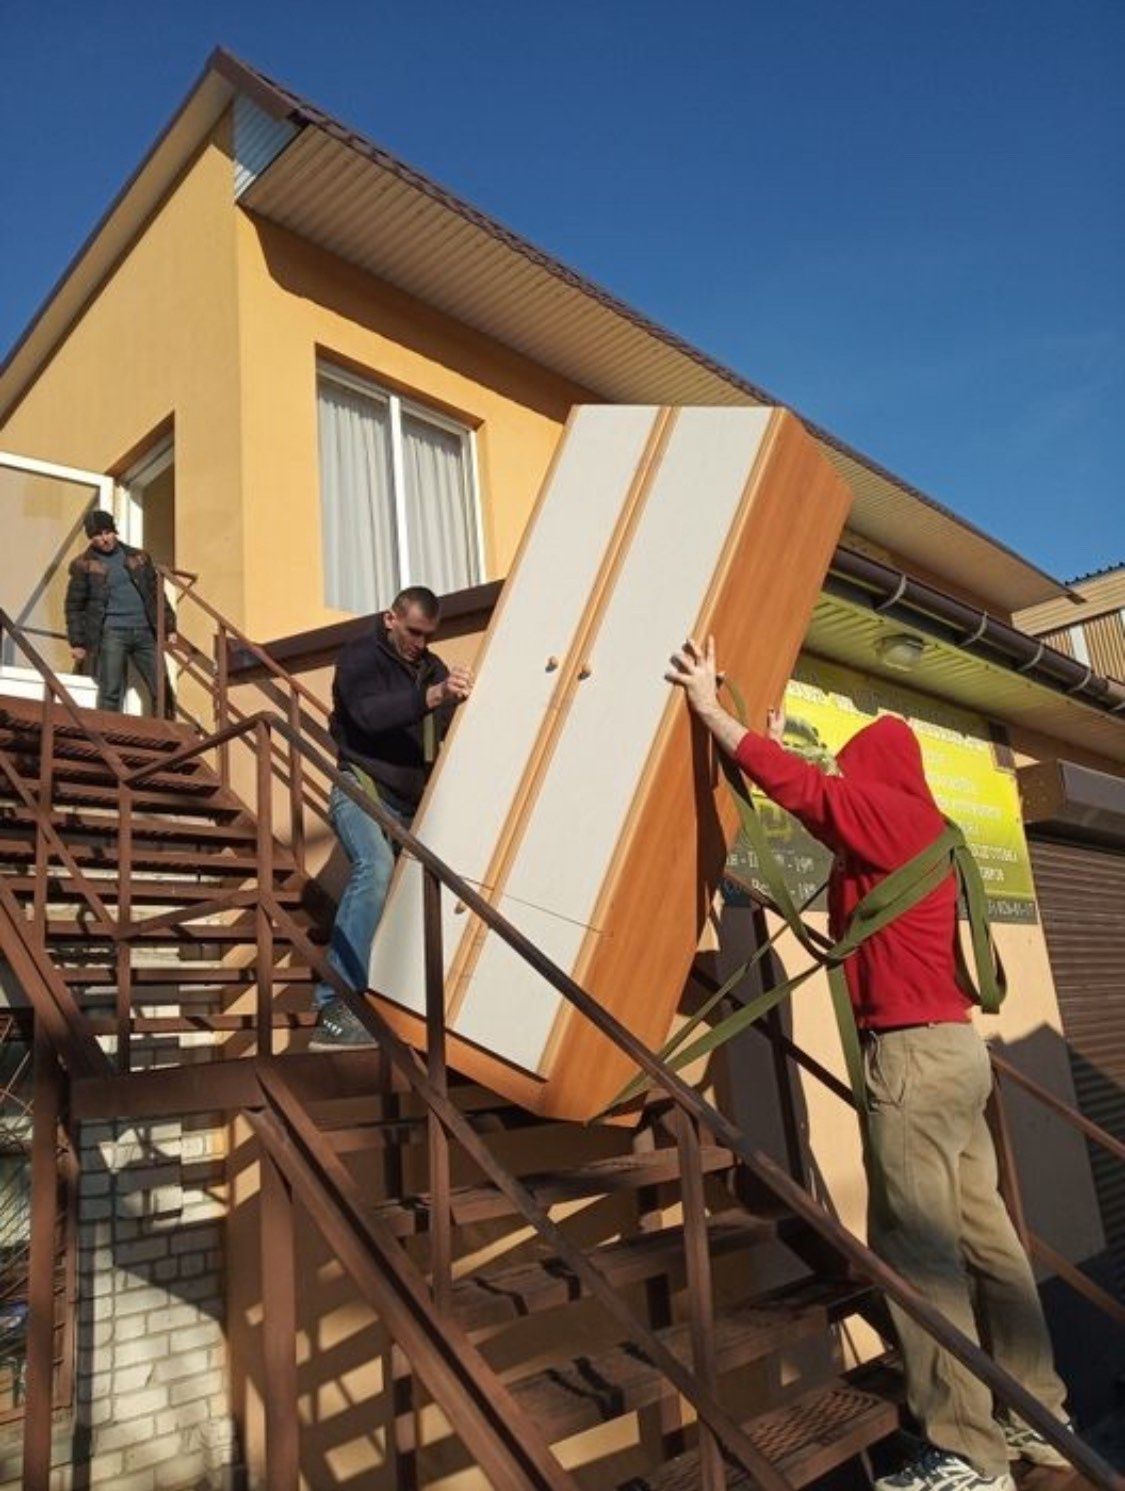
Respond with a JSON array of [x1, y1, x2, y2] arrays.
[[864, 1024, 1065, 1476]]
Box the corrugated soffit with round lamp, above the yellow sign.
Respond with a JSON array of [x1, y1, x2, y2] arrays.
[[805, 595, 1125, 762]]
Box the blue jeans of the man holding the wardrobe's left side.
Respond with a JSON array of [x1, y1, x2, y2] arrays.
[[314, 774, 411, 1009]]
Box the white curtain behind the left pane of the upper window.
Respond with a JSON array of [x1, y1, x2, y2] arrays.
[[317, 379, 399, 616]]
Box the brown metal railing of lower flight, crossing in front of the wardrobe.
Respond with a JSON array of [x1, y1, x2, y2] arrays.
[[118, 713, 1121, 1491]]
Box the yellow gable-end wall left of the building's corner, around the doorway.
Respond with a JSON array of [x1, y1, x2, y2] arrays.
[[0, 121, 243, 619]]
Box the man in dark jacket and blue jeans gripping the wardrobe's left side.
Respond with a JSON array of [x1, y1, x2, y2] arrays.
[[310, 584, 472, 1051]]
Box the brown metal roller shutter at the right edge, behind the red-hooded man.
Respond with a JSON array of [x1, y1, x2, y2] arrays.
[[1030, 839, 1125, 1278]]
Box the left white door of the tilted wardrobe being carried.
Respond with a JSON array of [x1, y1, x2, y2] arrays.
[[371, 406, 659, 1011]]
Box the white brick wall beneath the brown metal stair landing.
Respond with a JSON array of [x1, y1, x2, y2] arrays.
[[0, 1115, 241, 1491]]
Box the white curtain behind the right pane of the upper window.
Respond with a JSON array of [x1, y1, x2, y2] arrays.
[[402, 414, 480, 595]]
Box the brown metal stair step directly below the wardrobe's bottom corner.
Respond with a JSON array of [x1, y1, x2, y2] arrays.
[[371, 1145, 735, 1238]]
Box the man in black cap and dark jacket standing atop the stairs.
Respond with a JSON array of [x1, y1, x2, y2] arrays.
[[66, 510, 176, 714]]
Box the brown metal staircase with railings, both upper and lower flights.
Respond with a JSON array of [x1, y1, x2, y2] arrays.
[[0, 590, 1121, 1491]]
